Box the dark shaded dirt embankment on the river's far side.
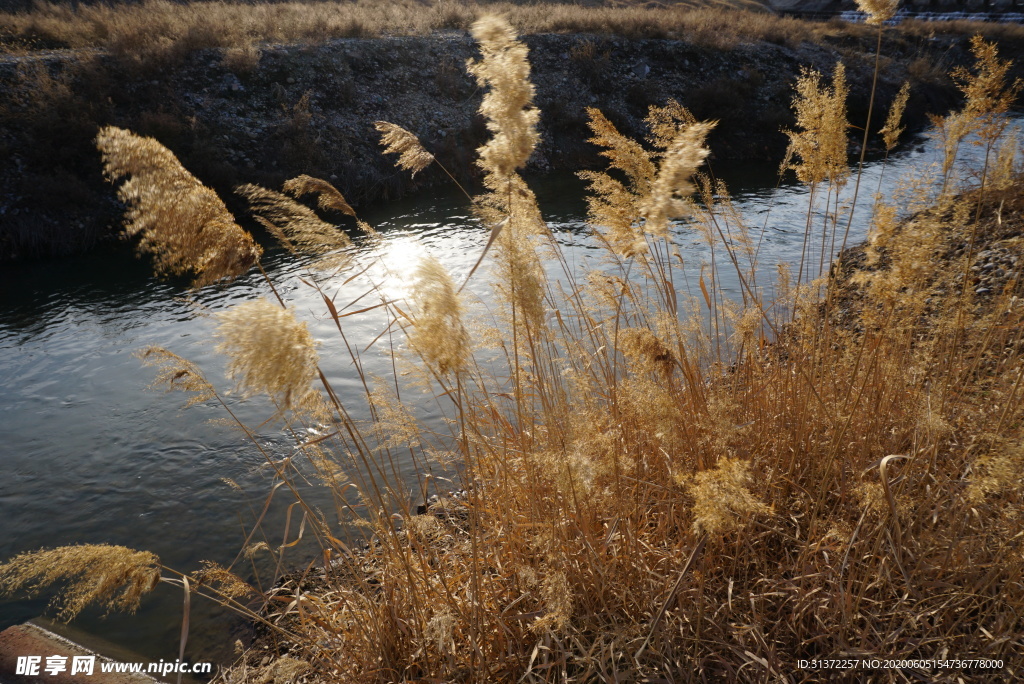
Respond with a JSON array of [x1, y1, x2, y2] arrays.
[[0, 32, 969, 260]]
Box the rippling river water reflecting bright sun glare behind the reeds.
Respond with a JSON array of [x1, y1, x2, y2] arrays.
[[0, 120, 1007, 661]]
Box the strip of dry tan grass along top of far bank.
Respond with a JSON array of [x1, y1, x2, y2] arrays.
[[0, 0, 813, 57]]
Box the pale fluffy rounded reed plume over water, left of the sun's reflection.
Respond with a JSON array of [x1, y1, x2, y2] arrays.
[[216, 299, 318, 410]]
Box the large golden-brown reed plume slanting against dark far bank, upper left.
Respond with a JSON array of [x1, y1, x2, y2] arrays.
[[96, 126, 262, 288]]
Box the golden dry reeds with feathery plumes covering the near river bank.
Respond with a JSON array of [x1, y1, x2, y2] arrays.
[[0, 13, 1024, 682]]
